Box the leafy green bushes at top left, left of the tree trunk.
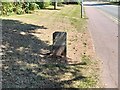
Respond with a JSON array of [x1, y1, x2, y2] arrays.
[[1, 1, 50, 15]]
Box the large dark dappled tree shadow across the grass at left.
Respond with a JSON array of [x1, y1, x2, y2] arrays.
[[1, 19, 85, 88]]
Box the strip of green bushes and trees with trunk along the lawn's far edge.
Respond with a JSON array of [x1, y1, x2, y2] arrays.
[[0, 0, 79, 15]]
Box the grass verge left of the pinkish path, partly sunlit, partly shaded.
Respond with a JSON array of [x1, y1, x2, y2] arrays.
[[2, 5, 99, 88]]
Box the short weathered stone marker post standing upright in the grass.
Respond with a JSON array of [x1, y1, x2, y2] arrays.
[[52, 32, 67, 57]]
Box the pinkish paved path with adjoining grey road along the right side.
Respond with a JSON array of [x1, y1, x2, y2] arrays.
[[85, 3, 118, 88]]
